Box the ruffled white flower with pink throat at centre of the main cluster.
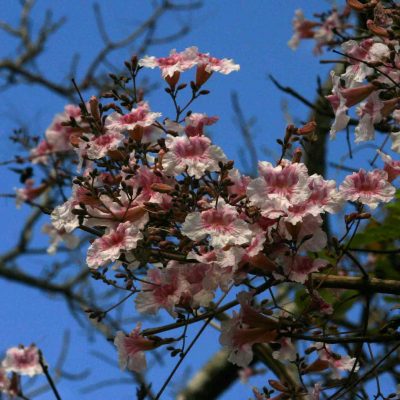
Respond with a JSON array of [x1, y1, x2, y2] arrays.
[[182, 200, 252, 248]]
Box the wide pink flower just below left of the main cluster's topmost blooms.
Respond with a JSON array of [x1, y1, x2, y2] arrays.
[[106, 102, 161, 132]]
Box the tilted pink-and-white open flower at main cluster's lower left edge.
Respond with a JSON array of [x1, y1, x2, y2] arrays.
[[86, 221, 143, 268]]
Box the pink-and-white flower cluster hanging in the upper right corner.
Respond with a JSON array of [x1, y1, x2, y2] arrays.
[[289, 0, 400, 152]]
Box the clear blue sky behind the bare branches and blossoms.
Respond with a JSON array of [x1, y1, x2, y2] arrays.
[[0, 0, 388, 400]]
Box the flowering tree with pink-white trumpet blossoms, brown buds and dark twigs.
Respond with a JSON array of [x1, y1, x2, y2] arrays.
[[0, 0, 400, 400]]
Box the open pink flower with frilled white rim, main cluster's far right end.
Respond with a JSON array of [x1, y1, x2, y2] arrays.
[[339, 169, 396, 208]]
